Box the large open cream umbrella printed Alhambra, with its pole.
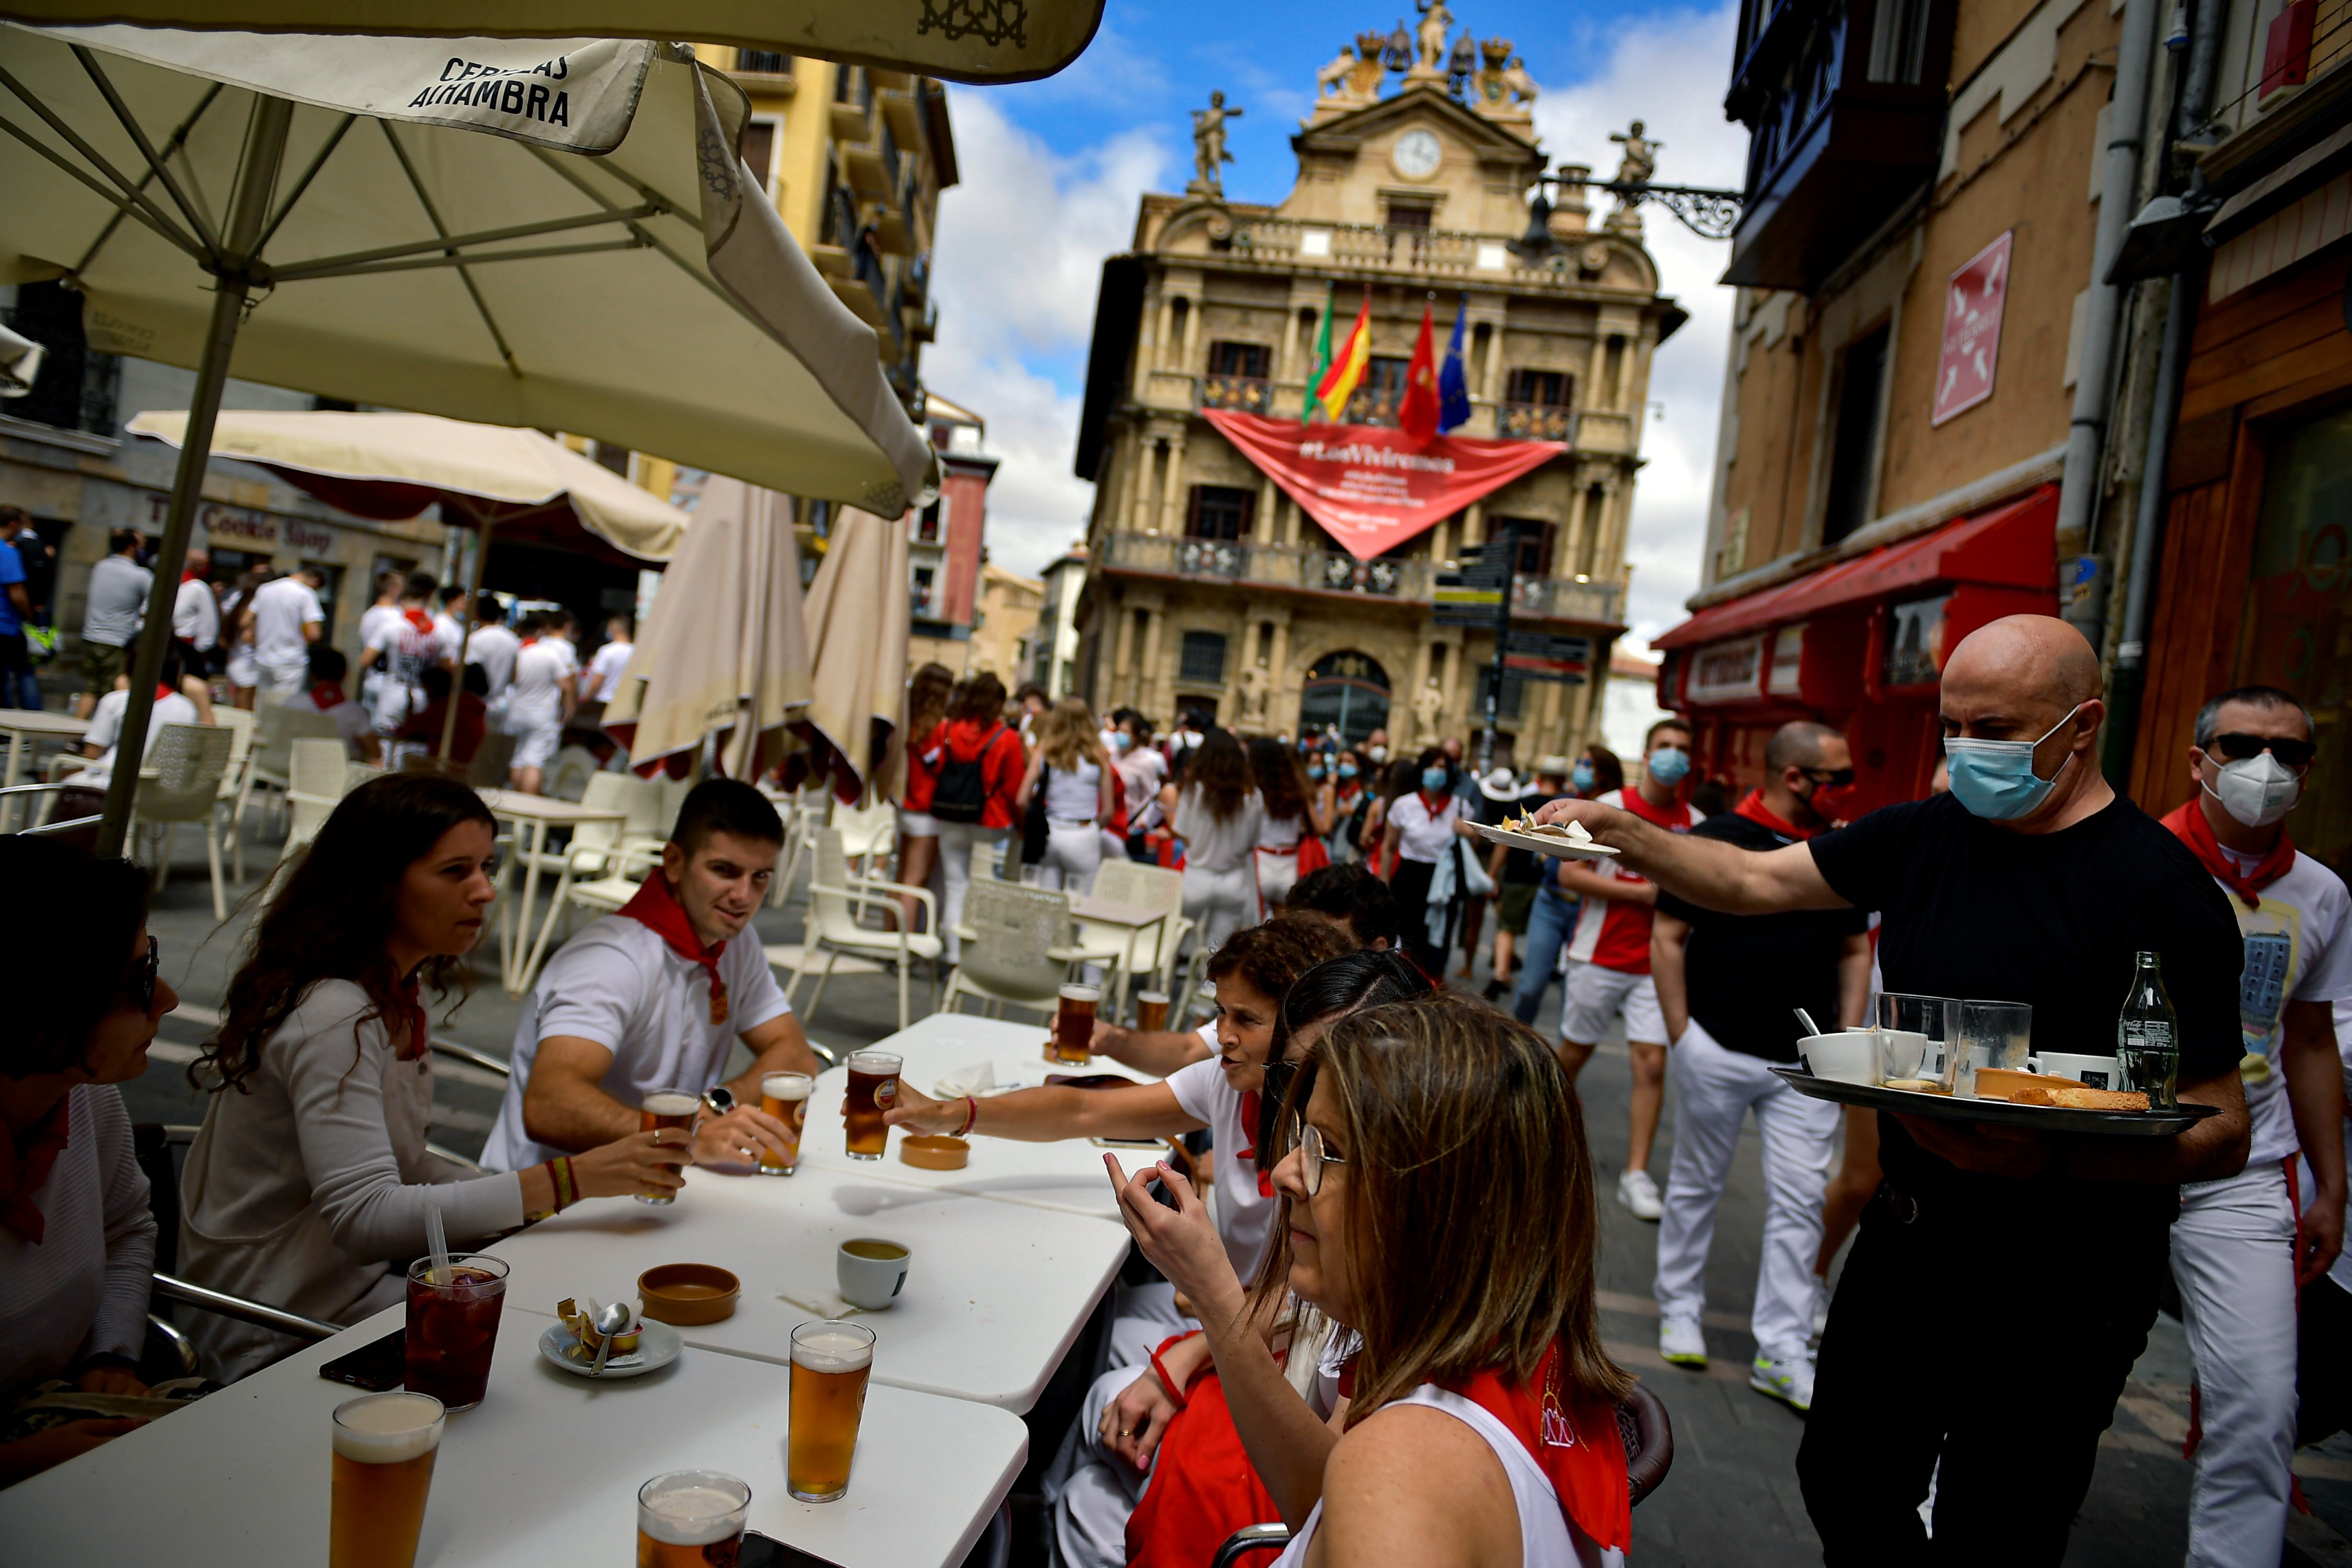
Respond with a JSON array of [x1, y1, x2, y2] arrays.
[[0, 26, 936, 854]]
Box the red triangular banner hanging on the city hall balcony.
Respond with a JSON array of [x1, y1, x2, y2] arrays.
[[1204, 409, 1569, 562]]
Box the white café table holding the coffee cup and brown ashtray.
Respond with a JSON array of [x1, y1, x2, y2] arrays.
[[489, 1166, 1127, 1413]]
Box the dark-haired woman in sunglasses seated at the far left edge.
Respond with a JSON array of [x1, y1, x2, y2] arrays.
[[0, 837, 179, 1486]]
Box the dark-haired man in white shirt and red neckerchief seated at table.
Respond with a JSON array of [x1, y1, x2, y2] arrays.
[[482, 778, 818, 1171]]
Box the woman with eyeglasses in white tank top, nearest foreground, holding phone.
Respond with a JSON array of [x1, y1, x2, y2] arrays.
[[1105, 997, 1632, 1568]]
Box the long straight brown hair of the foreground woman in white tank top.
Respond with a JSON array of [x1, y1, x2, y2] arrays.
[[1251, 992, 1632, 1425]]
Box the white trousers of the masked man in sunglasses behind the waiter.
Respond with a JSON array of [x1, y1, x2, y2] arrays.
[[2173, 1161, 2296, 1568]]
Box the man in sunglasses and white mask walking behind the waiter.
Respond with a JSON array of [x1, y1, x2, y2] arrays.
[[2164, 686, 2352, 1568]]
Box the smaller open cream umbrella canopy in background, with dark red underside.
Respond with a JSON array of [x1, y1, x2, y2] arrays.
[[127, 409, 691, 562]]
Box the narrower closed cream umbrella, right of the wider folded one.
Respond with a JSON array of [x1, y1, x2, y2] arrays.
[[786, 508, 913, 802]]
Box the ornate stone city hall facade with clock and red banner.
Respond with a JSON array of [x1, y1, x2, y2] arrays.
[[1077, 15, 1684, 766]]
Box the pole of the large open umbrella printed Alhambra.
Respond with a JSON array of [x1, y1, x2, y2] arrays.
[[99, 94, 294, 858]]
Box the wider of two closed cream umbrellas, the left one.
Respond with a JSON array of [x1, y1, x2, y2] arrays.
[[605, 477, 809, 778]]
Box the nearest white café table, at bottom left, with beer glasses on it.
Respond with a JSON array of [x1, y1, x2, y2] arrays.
[[0, 1300, 1028, 1568]]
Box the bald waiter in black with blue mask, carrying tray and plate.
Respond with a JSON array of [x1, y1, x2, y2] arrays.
[[1538, 616, 2249, 1568]]
